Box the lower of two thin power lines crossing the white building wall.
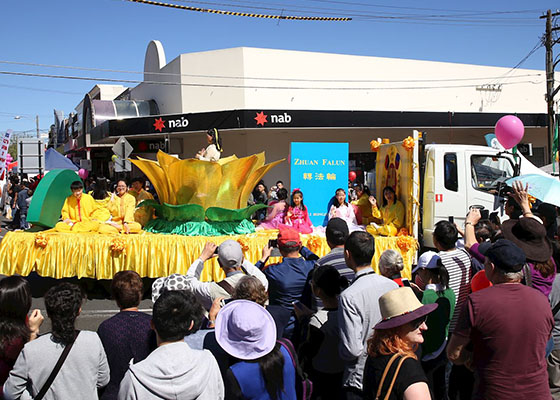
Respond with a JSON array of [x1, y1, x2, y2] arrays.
[[0, 71, 540, 91]]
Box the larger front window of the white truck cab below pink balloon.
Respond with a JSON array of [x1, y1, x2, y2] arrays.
[[471, 155, 513, 190]]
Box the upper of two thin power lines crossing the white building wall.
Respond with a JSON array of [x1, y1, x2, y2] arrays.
[[0, 59, 542, 83]]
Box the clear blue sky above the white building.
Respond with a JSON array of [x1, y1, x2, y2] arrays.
[[0, 0, 560, 131]]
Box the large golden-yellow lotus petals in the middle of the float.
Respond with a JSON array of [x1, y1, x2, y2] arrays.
[[131, 151, 284, 209]]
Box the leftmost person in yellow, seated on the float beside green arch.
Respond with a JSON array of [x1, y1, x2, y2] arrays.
[[54, 181, 105, 233]]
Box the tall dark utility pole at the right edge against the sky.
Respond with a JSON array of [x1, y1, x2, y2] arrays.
[[540, 10, 560, 170]]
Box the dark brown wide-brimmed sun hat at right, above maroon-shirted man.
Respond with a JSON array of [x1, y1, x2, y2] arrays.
[[502, 217, 552, 262]]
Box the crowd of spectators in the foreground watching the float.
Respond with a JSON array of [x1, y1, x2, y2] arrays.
[[0, 184, 560, 400]]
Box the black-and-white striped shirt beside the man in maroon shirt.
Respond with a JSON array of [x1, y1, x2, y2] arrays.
[[438, 249, 471, 335]]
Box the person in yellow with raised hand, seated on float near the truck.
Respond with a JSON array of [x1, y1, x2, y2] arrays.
[[366, 186, 404, 236]]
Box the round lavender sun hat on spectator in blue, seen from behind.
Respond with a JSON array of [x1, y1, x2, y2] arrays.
[[216, 300, 276, 360]]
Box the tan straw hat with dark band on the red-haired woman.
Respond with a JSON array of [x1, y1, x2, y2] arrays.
[[373, 287, 438, 329]]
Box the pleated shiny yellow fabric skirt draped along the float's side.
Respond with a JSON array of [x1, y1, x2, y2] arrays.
[[0, 230, 414, 281]]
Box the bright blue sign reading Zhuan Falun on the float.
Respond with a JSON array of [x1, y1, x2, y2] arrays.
[[290, 142, 348, 226]]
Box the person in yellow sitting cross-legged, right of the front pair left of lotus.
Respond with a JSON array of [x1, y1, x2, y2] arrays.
[[99, 179, 142, 233]]
